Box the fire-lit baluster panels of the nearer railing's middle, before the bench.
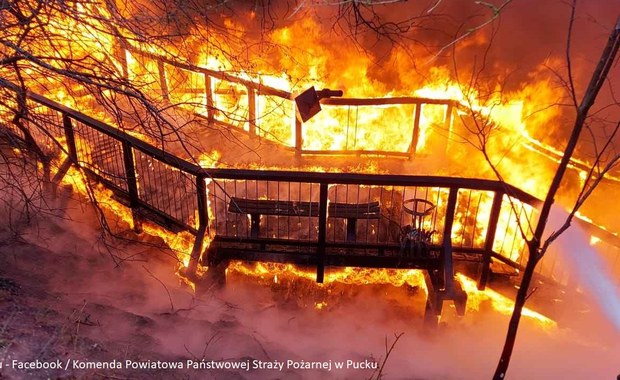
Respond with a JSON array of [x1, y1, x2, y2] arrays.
[[209, 180, 509, 251]]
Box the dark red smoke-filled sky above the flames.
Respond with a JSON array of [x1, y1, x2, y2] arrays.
[[208, 0, 620, 87]]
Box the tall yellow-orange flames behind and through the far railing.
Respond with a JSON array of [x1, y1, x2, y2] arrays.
[[10, 0, 557, 186]]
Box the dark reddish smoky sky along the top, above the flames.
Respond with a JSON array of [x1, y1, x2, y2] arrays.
[[128, 0, 620, 84]]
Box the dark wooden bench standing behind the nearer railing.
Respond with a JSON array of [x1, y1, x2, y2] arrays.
[[228, 197, 381, 242]]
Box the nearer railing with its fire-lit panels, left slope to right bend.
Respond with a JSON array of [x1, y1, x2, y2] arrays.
[[0, 81, 534, 282]]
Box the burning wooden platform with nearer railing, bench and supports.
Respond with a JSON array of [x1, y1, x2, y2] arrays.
[[1, 81, 552, 321]]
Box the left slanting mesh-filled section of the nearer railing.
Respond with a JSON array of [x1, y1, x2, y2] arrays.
[[3, 83, 208, 265]]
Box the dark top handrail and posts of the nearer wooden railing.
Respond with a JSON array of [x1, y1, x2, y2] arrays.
[[0, 79, 541, 278]]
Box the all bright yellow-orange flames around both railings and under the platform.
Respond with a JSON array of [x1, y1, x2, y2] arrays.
[[6, 2, 616, 326]]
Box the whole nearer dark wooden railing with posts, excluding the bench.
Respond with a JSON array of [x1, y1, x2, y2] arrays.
[[0, 81, 539, 296]]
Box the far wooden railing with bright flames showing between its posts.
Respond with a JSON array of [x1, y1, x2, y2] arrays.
[[119, 42, 458, 158]]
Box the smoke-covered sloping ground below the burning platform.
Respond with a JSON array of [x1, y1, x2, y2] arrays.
[[0, 193, 620, 379]]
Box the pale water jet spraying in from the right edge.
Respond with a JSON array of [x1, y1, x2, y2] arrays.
[[549, 207, 620, 332]]
